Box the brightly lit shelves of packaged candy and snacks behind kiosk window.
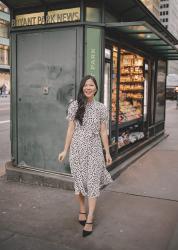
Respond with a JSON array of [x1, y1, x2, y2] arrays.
[[118, 49, 144, 124]]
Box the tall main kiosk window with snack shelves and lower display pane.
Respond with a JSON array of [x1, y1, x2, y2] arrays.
[[118, 49, 144, 149]]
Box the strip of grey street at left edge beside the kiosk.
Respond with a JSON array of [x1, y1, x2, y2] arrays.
[[0, 96, 10, 176]]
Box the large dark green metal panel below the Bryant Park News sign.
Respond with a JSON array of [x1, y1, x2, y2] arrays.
[[17, 28, 79, 172]]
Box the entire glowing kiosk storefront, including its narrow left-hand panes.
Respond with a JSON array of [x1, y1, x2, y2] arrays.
[[104, 46, 148, 149]]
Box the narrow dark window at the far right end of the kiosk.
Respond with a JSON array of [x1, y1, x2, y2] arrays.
[[155, 60, 166, 122]]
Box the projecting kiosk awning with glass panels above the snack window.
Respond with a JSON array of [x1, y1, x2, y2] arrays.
[[106, 21, 178, 60]]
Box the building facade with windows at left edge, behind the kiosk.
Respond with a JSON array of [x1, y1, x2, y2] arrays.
[[0, 1, 10, 93]]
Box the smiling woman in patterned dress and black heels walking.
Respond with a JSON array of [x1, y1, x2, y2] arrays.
[[58, 75, 112, 237]]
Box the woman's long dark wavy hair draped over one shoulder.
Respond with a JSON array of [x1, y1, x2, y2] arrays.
[[75, 75, 98, 125]]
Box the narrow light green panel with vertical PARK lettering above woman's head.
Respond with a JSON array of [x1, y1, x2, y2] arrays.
[[85, 27, 102, 100]]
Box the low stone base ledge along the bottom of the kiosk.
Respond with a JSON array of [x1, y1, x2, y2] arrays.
[[5, 134, 168, 191]]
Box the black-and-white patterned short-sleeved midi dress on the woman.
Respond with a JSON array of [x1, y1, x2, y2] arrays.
[[66, 100, 113, 198]]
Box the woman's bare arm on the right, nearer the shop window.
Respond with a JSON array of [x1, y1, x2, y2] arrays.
[[100, 122, 112, 165]]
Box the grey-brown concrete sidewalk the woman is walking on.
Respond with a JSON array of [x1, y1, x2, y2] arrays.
[[0, 102, 178, 250]]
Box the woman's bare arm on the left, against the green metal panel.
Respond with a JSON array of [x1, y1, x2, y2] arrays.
[[58, 120, 75, 161]]
